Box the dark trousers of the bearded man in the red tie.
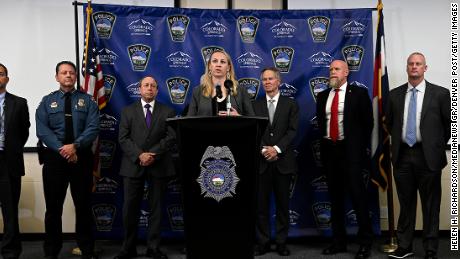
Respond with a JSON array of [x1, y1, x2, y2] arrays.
[[321, 140, 373, 246]]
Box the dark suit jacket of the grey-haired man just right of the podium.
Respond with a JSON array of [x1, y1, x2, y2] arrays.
[[253, 96, 299, 174]]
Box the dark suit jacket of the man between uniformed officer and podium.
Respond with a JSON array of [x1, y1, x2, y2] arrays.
[[118, 100, 175, 177]]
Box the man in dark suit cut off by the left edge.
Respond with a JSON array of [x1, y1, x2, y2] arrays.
[[0, 63, 30, 259]]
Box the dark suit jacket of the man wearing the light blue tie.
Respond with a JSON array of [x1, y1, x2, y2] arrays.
[[386, 81, 451, 171]]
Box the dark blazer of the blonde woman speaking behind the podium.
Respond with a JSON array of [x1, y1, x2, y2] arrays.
[[187, 85, 254, 116]]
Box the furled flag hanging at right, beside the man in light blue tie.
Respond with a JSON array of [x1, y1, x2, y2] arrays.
[[371, 0, 391, 190]]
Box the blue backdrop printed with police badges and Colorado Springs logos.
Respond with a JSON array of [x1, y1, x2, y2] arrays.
[[85, 4, 380, 239]]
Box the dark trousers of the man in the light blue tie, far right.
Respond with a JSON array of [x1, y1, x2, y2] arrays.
[[394, 144, 441, 252]]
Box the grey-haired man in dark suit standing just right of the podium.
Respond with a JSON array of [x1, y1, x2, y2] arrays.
[[253, 67, 299, 256]]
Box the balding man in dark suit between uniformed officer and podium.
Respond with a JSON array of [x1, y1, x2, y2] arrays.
[[115, 76, 175, 259]]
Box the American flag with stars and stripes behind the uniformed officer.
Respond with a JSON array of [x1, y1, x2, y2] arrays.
[[80, 2, 107, 109]]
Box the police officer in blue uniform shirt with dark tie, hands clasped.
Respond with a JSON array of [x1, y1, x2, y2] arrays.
[[35, 61, 99, 259]]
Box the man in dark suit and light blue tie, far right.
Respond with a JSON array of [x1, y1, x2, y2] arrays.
[[387, 52, 451, 258]]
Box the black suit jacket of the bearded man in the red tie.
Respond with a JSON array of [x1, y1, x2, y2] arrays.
[[316, 84, 374, 162]]
